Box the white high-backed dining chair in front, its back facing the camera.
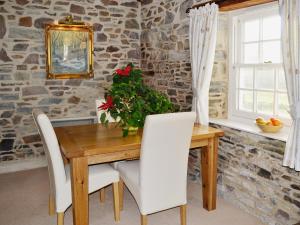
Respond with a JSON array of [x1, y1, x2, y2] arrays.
[[118, 112, 196, 225]]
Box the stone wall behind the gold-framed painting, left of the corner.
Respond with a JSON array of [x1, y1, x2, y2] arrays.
[[0, 0, 141, 163]]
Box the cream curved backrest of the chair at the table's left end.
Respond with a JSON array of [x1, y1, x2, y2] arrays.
[[32, 109, 67, 196]]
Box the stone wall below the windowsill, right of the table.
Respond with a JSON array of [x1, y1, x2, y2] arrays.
[[205, 124, 300, 225]]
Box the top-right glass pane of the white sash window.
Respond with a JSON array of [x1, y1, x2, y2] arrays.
[[263, 16, 281, 40]]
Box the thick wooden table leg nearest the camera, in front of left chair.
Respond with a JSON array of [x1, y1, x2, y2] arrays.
[[71, 157, 89, 225]]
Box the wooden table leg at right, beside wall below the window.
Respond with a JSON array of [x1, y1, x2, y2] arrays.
[[201, 137, 219, 211]]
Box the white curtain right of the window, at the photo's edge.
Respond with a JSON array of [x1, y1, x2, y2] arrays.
[[279, 0, 300, 171]]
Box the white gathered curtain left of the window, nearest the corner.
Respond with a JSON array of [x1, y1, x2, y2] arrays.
[[189, 3, 219, 125]]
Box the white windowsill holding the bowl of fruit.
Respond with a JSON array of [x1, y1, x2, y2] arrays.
[[209, 118, 289, 142]]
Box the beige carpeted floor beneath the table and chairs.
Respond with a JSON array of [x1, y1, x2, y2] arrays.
[[0, 168, 262, 225]]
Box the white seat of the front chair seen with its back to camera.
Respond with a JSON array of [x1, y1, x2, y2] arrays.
[[117, 160, 140, 206]]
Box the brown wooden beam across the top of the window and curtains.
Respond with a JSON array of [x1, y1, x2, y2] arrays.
[[186, 0, 278, 13]]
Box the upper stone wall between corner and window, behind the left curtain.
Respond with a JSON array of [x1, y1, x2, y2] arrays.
[[141, 0, 228, 115]]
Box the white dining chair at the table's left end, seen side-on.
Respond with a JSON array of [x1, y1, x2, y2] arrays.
[[32, 109, 120, 225]]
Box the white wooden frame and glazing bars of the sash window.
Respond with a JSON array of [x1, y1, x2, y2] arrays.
[[228, 3, 291, 125]]
